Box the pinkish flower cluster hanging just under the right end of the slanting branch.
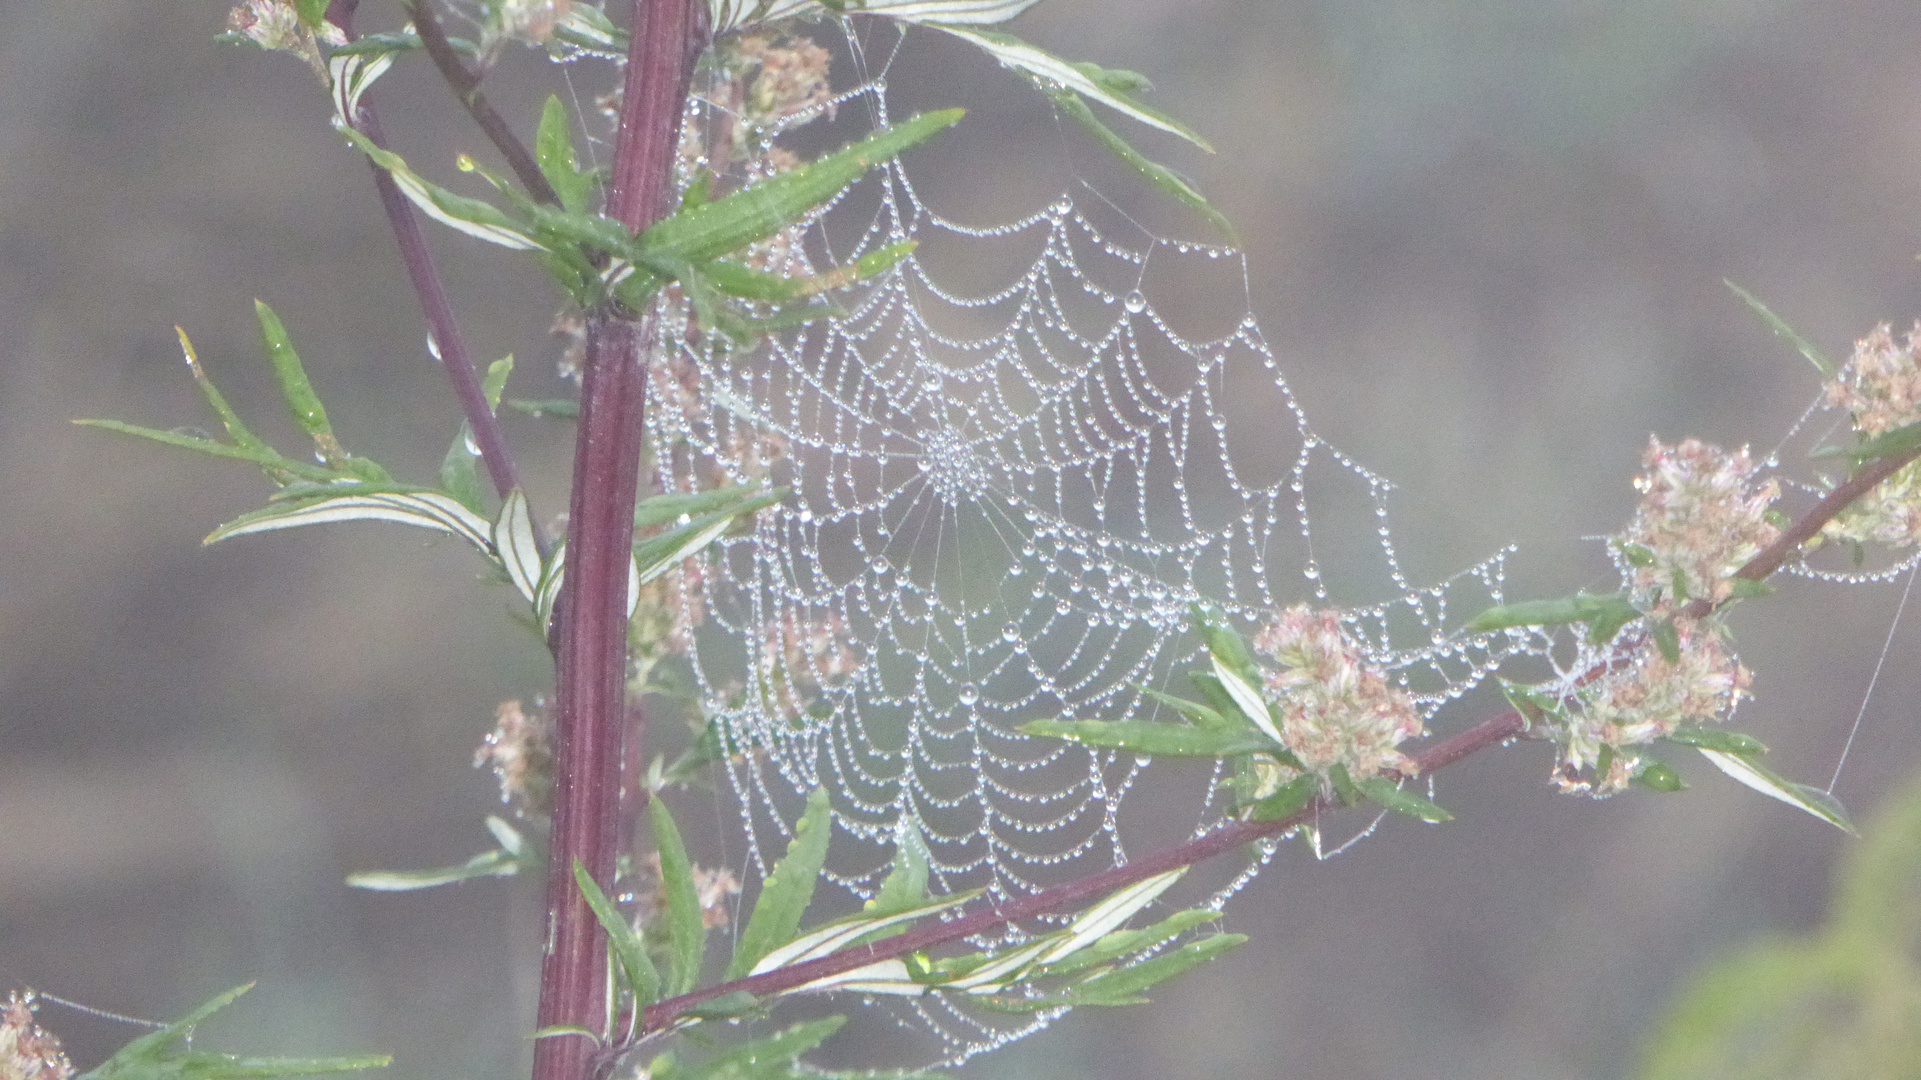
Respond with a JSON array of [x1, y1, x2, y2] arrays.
[[1556, 619, 1754, 796]]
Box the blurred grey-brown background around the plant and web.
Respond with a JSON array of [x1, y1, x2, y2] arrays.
[[0, 0, 1921, 1080]]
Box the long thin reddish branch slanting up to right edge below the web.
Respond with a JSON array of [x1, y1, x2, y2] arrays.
[[640, 434, 1921, 1036]]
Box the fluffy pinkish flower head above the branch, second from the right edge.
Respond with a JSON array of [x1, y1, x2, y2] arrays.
[[1617, 438, 1781, 613]]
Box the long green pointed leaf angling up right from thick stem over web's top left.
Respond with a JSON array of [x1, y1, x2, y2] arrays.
[[636, 110, 962, 275]]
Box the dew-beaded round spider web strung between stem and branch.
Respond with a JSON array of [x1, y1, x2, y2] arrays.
[[607, 16, 1521, 1063]]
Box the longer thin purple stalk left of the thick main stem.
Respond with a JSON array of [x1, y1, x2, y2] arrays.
[[327, 0, 521, 498]]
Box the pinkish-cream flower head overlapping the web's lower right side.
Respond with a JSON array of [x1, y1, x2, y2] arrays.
[[1254, 603, 1425, 780]]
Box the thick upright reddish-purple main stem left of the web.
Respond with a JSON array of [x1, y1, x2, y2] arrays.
[[534, 0, 707, 1080]]
